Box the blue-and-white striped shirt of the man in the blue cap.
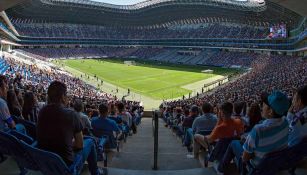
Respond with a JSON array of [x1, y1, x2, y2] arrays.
[[243, 118, 289, 165]]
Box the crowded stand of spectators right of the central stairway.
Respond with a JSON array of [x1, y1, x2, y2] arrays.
[[161, 56, 307, 174]]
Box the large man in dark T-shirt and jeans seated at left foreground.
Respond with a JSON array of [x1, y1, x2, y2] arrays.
[[37, 81, 103, 175]]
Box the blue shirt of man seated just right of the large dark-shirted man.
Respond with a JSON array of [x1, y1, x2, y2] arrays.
[[92, 117, 120, 137]]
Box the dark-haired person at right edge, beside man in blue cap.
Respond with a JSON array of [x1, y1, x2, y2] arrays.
[[287, 85, 307, 146]]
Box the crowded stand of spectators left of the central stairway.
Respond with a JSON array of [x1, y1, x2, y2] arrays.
[[0, 55, 143, 175]]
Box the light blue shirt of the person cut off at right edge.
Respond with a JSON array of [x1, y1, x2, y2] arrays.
[[287, 107, 307, 146]]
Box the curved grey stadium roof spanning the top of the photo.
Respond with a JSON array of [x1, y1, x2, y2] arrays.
[[6, 0, 302, 27]]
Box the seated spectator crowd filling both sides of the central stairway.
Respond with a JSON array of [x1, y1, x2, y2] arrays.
[[0, 51, 307, 174]]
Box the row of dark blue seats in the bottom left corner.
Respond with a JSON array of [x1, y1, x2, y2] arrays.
[[0, 128, 106, 175]]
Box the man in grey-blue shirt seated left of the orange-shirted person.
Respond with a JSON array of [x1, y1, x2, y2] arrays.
[[192, 103, 217, 133]]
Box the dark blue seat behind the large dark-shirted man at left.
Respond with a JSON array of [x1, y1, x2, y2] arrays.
[[21, 142, 83, 175]]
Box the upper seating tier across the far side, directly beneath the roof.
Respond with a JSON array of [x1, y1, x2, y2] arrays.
[[12, 19, 269, 39]]
